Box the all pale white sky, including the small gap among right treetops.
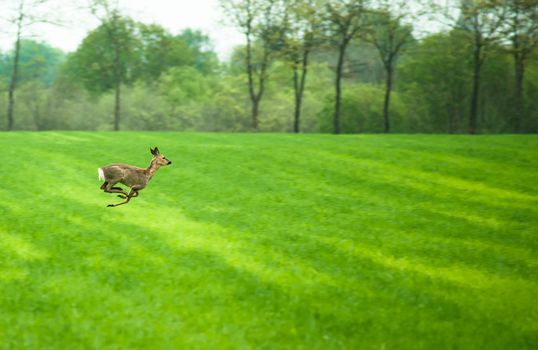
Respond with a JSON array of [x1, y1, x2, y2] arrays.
[[0, 0, 440, 60]]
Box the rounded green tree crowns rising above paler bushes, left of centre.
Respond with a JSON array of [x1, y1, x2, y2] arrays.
[[65, 21, 218, 97]]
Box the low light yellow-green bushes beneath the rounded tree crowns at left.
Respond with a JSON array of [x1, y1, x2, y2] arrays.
[[49, 67, 248, 131]]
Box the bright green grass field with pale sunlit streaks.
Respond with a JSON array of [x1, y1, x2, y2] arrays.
[[0, 132, 538, 350]]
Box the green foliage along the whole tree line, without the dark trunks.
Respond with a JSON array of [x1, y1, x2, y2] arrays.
[[4, 6, 538, 133]]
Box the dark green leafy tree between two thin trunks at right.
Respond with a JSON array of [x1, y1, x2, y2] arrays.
[[399, 31, 471, 133]]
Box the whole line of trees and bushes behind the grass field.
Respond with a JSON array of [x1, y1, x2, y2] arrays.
[[0, 0, 538, 134]]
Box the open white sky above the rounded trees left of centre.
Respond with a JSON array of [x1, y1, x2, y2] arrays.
[[0, 0, 243, 59]]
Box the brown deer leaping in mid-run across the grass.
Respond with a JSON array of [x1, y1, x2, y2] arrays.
[[97, 147, 172, 207]]
